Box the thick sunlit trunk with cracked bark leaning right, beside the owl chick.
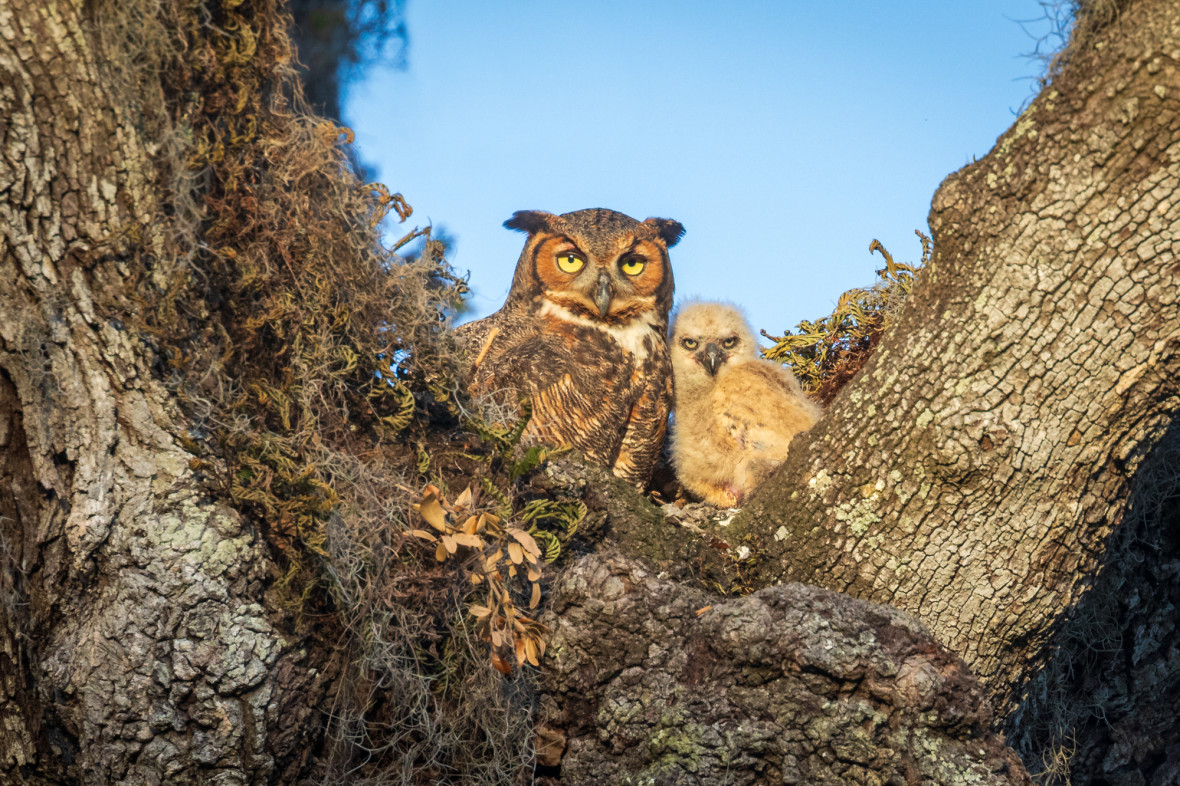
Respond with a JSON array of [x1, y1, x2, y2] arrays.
[[730, 0, 1180, 708]]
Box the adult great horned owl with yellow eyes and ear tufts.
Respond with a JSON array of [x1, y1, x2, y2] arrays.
[[457, 209, 684, 486]]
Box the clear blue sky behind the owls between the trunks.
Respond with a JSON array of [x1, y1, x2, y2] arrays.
[[345, 0, 1066, 333]]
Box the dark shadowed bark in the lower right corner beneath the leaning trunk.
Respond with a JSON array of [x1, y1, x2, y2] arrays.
[[1004, 420, 1180, 786]]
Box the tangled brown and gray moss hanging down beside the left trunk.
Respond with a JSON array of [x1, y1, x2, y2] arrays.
[[100, 0, 566, 784]]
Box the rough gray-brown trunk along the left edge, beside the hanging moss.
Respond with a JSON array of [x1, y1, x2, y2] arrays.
[[0, 0, 315, 784]]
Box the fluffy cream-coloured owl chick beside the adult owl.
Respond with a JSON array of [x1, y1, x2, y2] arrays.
[[671, 302, 822, 507]]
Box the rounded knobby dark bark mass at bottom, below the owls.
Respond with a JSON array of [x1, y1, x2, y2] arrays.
[[542, 552, 1031, 786]]
